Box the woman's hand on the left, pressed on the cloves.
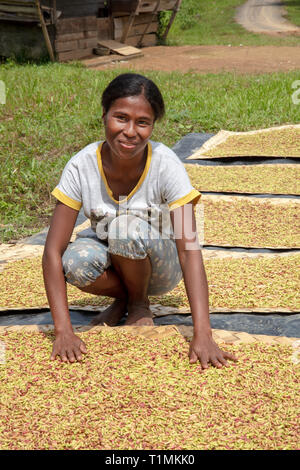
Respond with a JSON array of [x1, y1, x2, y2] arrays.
[[50, 331, 87, 362]]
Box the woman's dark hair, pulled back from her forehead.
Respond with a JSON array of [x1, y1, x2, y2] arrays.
[[102, 73, 165, 121]]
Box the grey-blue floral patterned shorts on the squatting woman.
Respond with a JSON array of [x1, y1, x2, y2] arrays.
[[62, 215, 182, 295]]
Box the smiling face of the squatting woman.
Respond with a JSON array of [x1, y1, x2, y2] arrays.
[[103, 95, 155, 160]]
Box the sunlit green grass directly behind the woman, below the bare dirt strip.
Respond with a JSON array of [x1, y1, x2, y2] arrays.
[[0, 62, 300, 242]]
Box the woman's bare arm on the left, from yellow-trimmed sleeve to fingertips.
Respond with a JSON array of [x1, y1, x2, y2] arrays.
[[42, 202, 86, 362]]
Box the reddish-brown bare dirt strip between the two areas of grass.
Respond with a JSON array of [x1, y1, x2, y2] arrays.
[[95, 46, 300, 73]]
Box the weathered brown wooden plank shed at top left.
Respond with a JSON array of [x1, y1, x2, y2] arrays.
[[0, 0, 181, 62]]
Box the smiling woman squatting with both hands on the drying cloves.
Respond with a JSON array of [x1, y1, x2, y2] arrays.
[[43, 74, 237, 368]]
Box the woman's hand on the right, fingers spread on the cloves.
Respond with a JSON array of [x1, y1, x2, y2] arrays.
[[189, 333, 238, 369]]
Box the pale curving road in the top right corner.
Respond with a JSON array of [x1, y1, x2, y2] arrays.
[[235, 0, 300, 33]]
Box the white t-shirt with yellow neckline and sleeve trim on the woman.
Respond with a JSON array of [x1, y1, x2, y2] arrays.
[[52, 141, 201, 240]]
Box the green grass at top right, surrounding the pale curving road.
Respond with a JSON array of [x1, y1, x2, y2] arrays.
[[166, 0, 300, 46]]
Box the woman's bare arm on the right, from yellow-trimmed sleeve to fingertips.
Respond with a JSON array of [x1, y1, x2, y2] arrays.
[[171, 203, 237, 369]]
